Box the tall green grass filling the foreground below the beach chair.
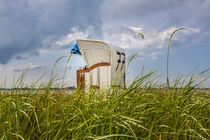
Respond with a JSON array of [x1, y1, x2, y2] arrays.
[[0, 69, 210, 139]]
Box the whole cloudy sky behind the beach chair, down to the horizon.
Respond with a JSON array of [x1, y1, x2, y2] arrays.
[[0, 0, 210, 87]]
